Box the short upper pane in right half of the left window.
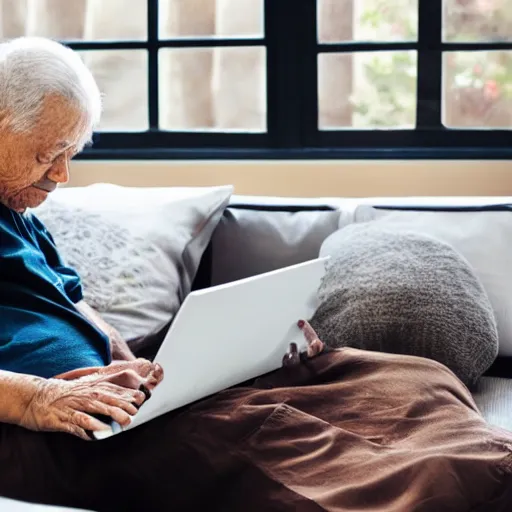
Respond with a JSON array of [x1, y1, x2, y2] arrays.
[[159, 0, 264, 39]]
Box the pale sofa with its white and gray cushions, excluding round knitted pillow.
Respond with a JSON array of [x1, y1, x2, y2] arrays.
[[4, 184, 512, 512]]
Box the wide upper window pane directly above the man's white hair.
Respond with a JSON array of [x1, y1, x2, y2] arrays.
[[0, 0, 147, 41]]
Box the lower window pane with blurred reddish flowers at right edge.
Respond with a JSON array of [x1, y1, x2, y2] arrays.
[[443, 51, 512, 128]]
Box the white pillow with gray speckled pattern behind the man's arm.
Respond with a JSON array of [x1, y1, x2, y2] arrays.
[[34, 184, 233, 341]]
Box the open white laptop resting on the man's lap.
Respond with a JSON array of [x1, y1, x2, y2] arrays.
[[95, 257, 329, 439]]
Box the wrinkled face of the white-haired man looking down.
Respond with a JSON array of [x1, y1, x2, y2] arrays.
[[0, 96, 87, 213]]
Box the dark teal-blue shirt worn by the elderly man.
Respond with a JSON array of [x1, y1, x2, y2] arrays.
[[0, 204, 111, 378]]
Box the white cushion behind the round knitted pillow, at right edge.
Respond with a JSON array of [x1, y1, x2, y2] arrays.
[[354, 205, 512, 356]]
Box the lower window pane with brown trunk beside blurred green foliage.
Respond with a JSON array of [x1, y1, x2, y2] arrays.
[[318, 51, 417, 130]]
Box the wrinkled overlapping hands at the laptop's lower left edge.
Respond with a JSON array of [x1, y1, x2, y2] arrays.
[[20, 359, 163, 440]]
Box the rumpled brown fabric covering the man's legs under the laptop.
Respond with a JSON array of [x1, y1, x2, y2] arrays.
[[0, 348, 512, 512]]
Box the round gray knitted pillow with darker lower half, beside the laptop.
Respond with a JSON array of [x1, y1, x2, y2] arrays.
[[311, 221, 498, 386]]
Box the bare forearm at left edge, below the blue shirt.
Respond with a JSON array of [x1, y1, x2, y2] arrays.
[[0, 370, 45, 425]]
